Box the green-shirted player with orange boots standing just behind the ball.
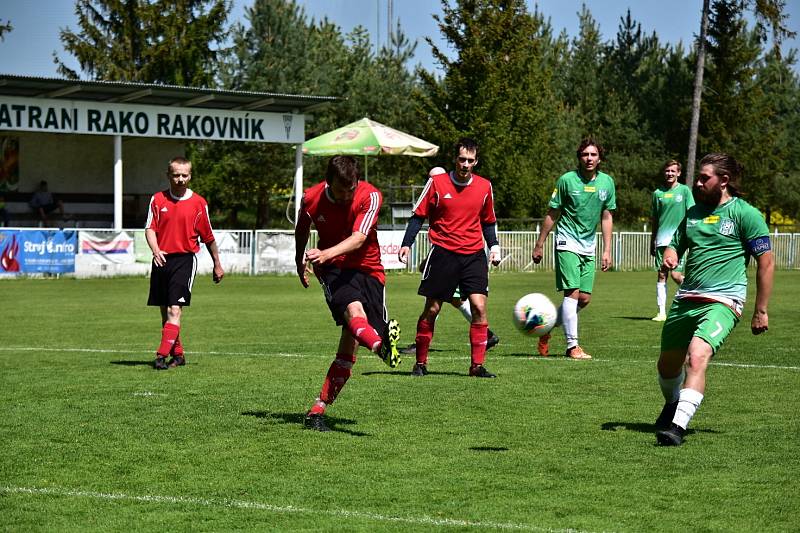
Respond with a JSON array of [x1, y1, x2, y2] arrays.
[[531, 137, 617, 359]]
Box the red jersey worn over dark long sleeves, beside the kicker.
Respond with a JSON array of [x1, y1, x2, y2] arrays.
[[414, 170, 497, 254]]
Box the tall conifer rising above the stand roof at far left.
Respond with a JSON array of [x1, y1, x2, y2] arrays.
[[53, 0, 231, 87]]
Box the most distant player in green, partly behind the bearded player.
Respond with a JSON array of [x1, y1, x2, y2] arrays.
[[650, 159, 694, 322]]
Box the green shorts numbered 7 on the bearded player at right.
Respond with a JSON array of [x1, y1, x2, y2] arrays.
[[661, 300, 739, 353]]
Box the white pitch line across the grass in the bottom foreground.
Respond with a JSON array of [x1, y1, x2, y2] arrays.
[[0, 487, 579, 533]]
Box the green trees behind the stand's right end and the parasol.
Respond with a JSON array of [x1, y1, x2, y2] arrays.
[[193, 0, 426, 228]]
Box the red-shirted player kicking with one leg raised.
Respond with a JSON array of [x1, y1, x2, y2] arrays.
[[295, 155, 400, 431]]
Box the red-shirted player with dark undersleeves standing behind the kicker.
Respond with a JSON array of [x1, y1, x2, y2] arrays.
[[398, 138, 500, 378]]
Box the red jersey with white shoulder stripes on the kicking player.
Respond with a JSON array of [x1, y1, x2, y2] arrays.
[[298, 181, 386, 283]]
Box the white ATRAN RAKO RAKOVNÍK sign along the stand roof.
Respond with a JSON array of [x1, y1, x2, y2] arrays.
[[0, 96, 305, 143]]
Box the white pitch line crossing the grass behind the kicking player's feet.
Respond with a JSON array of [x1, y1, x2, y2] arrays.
[[0, 346, 800, 371]]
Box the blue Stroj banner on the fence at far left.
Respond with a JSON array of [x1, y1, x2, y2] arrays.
[[0, 230, 78, 274]]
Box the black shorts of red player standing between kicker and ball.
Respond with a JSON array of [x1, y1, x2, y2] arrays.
[[417, 246, 489, 302]]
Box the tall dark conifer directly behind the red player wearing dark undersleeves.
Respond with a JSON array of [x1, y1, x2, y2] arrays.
[[419, 0, 574, 218]]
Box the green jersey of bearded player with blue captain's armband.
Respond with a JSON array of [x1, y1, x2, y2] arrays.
[[669, 197, 771, 315]]
